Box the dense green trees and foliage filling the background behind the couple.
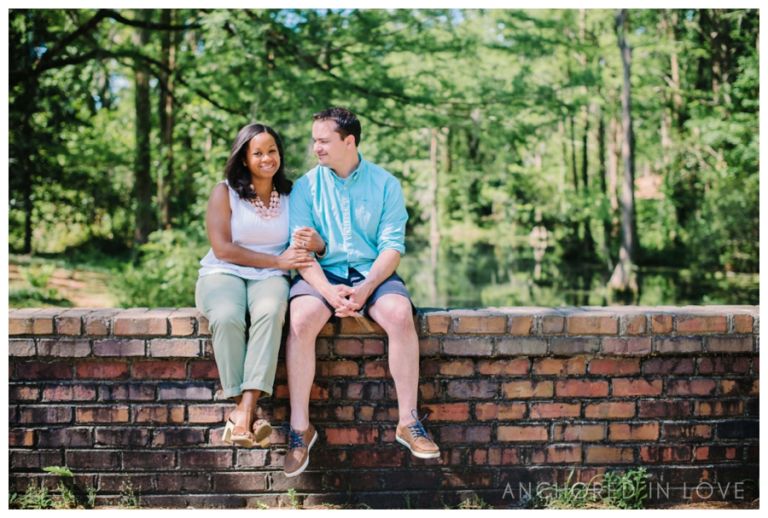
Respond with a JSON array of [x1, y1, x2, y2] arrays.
[[9, 9, 759, 306]]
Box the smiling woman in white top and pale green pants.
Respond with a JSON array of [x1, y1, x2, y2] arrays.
[[195, 124, 325, 447]]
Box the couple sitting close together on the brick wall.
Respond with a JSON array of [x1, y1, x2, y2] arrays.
[[195, 108, 440, 477]]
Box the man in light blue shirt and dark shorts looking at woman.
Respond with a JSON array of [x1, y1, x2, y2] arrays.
[[284, 108, 440, 477]]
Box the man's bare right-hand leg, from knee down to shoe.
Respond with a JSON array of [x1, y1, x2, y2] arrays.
[[368, 294, 419, 425]]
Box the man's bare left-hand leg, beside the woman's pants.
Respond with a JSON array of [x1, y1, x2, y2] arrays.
[[285, 295, 331, 430]]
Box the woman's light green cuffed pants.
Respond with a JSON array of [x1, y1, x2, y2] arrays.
[[195, 273, 288, 398]]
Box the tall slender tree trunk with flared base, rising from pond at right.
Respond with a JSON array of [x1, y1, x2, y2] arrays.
[[608, 9, 637, 293]]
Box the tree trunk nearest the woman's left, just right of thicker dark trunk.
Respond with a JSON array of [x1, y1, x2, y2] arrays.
[[157, 9, 178, 229]]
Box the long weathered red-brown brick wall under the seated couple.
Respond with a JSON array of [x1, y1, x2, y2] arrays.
[[9, 306, 759, 508]]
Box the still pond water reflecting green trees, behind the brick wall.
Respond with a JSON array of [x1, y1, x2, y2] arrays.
[[398, 240, 759, 307]]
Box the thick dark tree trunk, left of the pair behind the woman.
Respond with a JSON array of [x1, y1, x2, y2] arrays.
[[134, 9, 154, 244]]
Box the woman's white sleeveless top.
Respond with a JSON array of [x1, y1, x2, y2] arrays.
[[200, 180, 289, 281]]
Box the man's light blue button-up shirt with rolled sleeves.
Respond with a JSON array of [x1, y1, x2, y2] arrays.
[[290, 154, 408, 277]]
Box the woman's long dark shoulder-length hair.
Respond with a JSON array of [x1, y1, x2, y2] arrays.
[[224, 123, 293, 200]]
